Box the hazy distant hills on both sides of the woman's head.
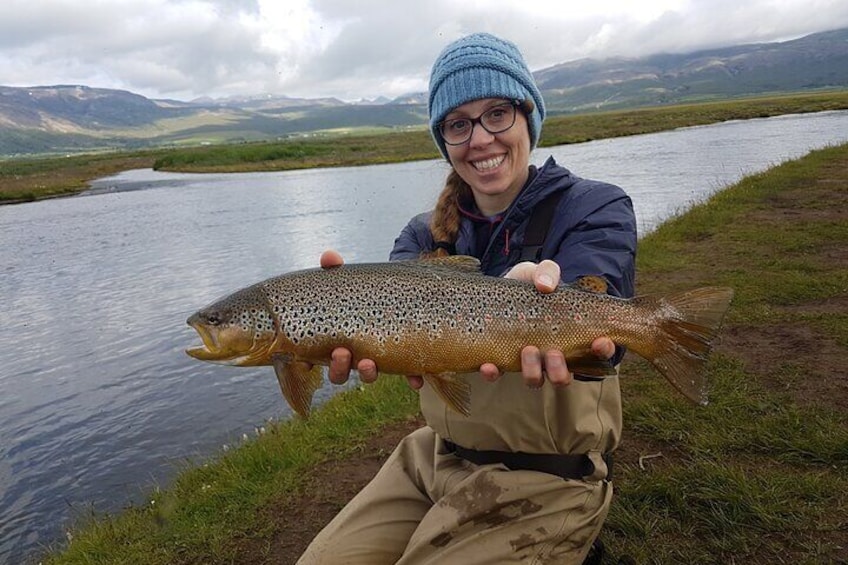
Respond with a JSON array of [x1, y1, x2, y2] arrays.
[[0, 29, 848, 156]]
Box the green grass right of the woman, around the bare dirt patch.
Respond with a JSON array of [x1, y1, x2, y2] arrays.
[[604, 145, 848, 564]]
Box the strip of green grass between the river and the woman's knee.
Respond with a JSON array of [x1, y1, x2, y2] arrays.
[[44, 377, 418, 565]]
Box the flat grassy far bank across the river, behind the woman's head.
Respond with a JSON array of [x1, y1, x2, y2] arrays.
[[0, 87, 848, 204]]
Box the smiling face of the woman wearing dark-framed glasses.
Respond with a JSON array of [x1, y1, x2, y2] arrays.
[[445, 98, 530, 216]]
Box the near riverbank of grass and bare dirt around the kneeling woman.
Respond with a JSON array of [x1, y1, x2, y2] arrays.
[[43, 145, 848, 565]]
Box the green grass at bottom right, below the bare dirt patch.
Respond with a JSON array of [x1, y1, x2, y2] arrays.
[[602, 356, 848, 564]]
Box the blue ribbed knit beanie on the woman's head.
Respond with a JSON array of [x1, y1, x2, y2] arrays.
[[428, 33, 545, 158]]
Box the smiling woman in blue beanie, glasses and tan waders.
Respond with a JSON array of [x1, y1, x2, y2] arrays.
[[299, 34, 636, 565]]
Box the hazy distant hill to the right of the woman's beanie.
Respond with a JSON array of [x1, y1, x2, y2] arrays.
[[534, 29, 848, 112]]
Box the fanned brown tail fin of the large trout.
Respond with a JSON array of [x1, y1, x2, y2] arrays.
[[632, 287, 733, 405]]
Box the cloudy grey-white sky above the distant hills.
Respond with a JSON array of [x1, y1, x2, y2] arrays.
[[0, 0, 848, 100]]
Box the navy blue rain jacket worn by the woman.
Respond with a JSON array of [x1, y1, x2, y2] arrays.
[[390, 157, 636, 298]]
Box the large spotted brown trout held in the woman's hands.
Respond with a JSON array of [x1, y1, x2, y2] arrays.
[[186, 256, 733, 417]]
